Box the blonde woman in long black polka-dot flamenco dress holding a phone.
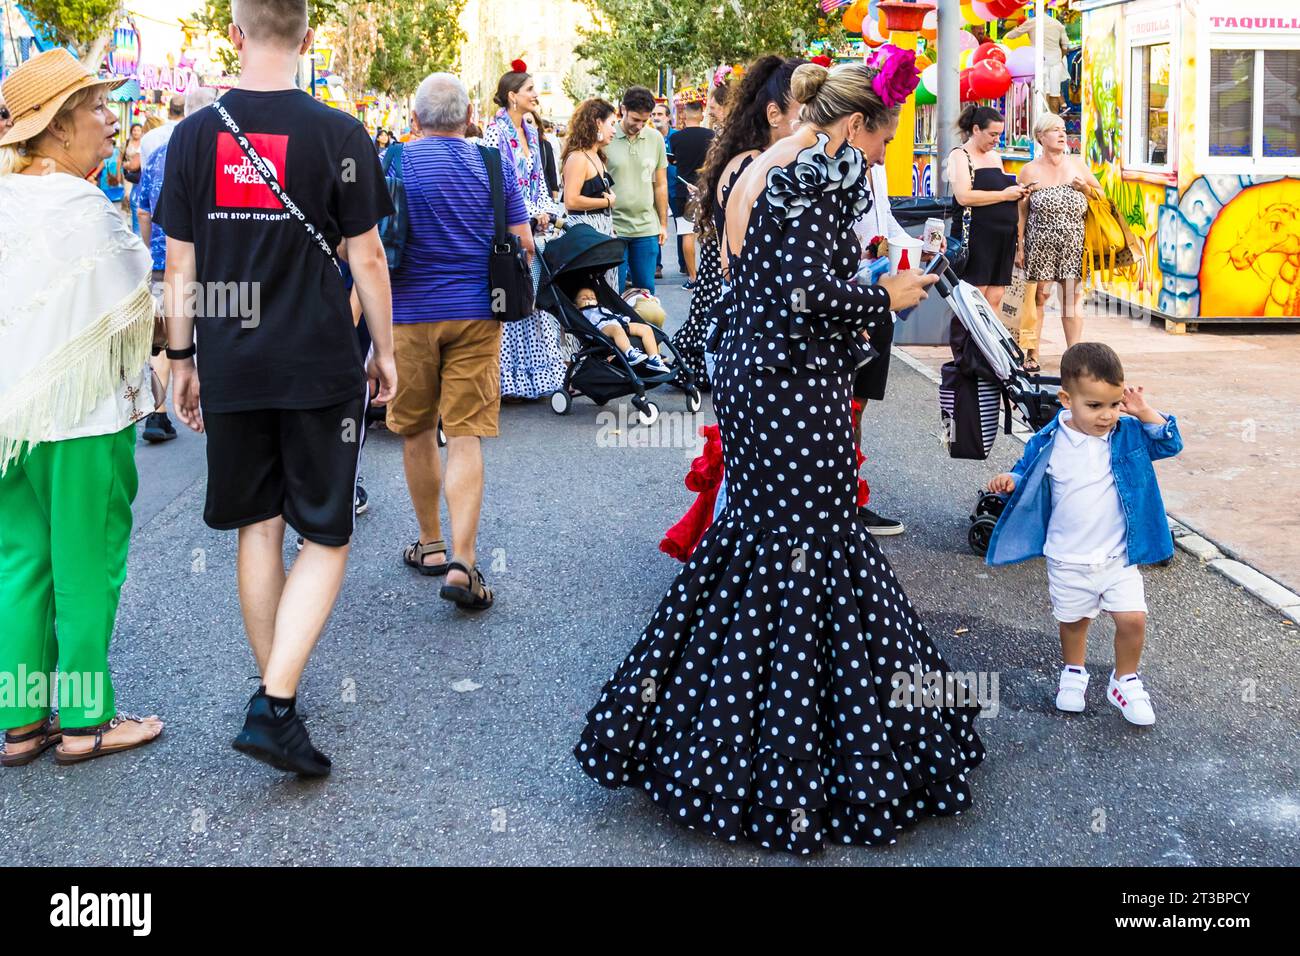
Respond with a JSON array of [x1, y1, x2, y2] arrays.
[[575, 64, 984, 853]]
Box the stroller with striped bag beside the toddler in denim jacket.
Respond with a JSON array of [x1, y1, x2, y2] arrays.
[[935, 269, 1061, 554]]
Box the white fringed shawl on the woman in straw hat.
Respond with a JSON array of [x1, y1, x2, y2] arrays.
[[0, 173, 153, 475]]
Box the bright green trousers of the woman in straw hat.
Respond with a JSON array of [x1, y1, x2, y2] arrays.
[[0, 425, 139, 730]]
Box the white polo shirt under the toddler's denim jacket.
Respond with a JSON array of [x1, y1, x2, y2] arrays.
[[1043, 411, 1128, 564]]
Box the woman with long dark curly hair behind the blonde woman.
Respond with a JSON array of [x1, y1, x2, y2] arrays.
[[672, 55, 803, 390]]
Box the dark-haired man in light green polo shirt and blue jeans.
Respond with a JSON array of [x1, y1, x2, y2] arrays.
[[605, 86, 668, 293]]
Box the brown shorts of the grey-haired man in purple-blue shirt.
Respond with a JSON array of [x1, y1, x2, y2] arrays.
[[387, 319, 501, 438]]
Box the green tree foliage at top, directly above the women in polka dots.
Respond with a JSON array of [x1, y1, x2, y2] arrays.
[[575, 0, 844, 96]]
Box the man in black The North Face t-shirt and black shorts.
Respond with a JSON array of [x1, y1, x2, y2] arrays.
[[155, 0, 397, 777]]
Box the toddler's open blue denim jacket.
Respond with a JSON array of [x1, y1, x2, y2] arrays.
[[985, 412, 1183, 564]]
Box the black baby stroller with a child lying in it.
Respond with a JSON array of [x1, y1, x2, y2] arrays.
[[537, 222, 702, 425]]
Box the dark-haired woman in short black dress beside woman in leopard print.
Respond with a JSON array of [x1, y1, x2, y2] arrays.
[[948, 103, 1030, 312]]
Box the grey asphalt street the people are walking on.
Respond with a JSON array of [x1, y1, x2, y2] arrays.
[[0, 278, 1300, 865]]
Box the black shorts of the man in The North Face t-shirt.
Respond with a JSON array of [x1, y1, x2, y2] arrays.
[[203, 392, 369, 548]]
